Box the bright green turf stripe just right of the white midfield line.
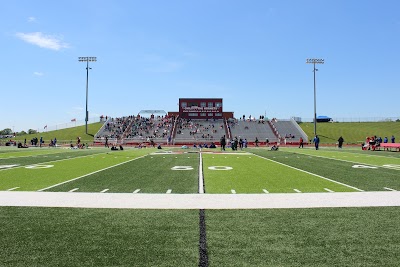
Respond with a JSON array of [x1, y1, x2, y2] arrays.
[[203, 154, 356, 193]]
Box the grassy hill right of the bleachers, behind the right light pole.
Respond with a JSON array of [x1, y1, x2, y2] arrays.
[[299, 122, 400, 144]]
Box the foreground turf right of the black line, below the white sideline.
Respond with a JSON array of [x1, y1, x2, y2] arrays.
[[205, 207, 400, 267]]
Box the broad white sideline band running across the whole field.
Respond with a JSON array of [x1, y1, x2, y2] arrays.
[[0, 191, 400, 209]]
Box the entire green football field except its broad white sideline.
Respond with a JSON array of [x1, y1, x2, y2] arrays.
[[0, 148, 400, 266]]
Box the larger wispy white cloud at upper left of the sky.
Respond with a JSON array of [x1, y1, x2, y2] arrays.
[[15, 32, 69, 51]]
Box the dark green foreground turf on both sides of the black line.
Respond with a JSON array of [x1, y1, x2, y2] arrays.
[[0, 207, 400, 266]]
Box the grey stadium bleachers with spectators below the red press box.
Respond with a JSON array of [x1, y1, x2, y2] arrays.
[[94, 116, 307, 145]]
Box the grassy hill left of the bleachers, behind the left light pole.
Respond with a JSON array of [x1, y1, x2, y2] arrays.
[[13, 122, 103, 145]]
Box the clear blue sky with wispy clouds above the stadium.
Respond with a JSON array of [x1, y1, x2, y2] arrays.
[[0, 0, 400, 131]]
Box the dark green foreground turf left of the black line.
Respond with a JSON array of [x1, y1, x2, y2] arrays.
[[0, 207, 199, 267]]
